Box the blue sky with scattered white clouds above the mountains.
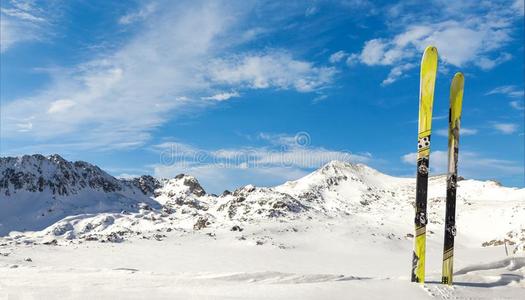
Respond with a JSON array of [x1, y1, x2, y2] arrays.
[[0, 0, 525, 192]]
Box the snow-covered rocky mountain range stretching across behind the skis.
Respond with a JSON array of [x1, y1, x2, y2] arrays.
[[0, 155, 525, 251]]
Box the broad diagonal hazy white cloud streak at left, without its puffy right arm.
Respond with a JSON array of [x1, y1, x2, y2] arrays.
[[1, 4, 229, 149]]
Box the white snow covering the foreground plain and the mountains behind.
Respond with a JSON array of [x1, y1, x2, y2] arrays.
[[0, 156, 525, 299]]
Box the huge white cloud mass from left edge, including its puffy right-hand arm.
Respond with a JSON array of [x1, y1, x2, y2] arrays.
[[0, 1, 335, 151]]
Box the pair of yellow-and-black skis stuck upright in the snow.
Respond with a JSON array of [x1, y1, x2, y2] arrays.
[[411, 46, 464, 284]]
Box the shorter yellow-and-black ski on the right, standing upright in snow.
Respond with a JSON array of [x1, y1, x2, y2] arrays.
[[441, 72, 465, 284]]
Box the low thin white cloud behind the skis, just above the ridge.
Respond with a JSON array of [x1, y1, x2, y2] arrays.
[[401, 149, 524, 179]]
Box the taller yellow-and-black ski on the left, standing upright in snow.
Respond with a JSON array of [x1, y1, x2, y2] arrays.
[[411, 46, 438, 283]]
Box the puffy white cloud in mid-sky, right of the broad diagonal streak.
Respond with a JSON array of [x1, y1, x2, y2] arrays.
[[210, 50, 336, 92]]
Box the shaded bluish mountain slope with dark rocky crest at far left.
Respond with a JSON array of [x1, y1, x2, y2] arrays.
[[0, 154, 158, 235]]
